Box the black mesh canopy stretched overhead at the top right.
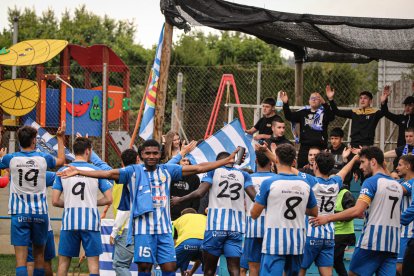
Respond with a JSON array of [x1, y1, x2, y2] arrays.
[[161, 0, 414, 63]]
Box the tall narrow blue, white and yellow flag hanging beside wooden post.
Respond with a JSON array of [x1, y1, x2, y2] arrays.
[[139, 25, 164, 140]]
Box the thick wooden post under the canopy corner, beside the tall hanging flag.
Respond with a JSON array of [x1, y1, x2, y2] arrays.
[[153, 22, 173, 142]]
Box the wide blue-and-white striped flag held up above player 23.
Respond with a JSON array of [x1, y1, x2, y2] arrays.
[[188, 119, 256, 171]]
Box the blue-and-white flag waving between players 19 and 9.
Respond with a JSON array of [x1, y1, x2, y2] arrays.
[[24, 118, 75, 161]]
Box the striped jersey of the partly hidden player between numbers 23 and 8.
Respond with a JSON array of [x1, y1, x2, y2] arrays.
[[245, 172, 275, 238]]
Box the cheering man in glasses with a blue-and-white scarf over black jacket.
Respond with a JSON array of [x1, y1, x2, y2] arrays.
[[280, 91, 335, 168]]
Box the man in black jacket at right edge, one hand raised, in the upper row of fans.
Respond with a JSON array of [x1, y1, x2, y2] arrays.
[[381, 90, 414, 147]]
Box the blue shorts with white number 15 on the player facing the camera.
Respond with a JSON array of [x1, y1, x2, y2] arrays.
[[134, 234, 176, 264]]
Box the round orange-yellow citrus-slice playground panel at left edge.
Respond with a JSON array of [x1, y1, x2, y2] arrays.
[[0, 79, 40, 116]]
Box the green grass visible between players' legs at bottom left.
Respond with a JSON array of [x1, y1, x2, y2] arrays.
[[0, 255, 88, 276]]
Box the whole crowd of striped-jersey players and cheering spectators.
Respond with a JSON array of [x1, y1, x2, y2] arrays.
[[0, 85, 414, 276]]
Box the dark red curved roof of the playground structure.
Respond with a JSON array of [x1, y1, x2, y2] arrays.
[[68, 44, 128, 72]]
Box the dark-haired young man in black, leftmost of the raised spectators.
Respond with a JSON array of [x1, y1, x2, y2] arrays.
[[246, 98, 280, 140]]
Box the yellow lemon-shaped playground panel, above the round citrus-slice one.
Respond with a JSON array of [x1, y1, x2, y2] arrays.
[[0, 39, 68, 66]]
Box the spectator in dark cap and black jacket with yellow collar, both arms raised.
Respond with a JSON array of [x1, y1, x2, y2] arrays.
[[326, 85, 389, 148]]
